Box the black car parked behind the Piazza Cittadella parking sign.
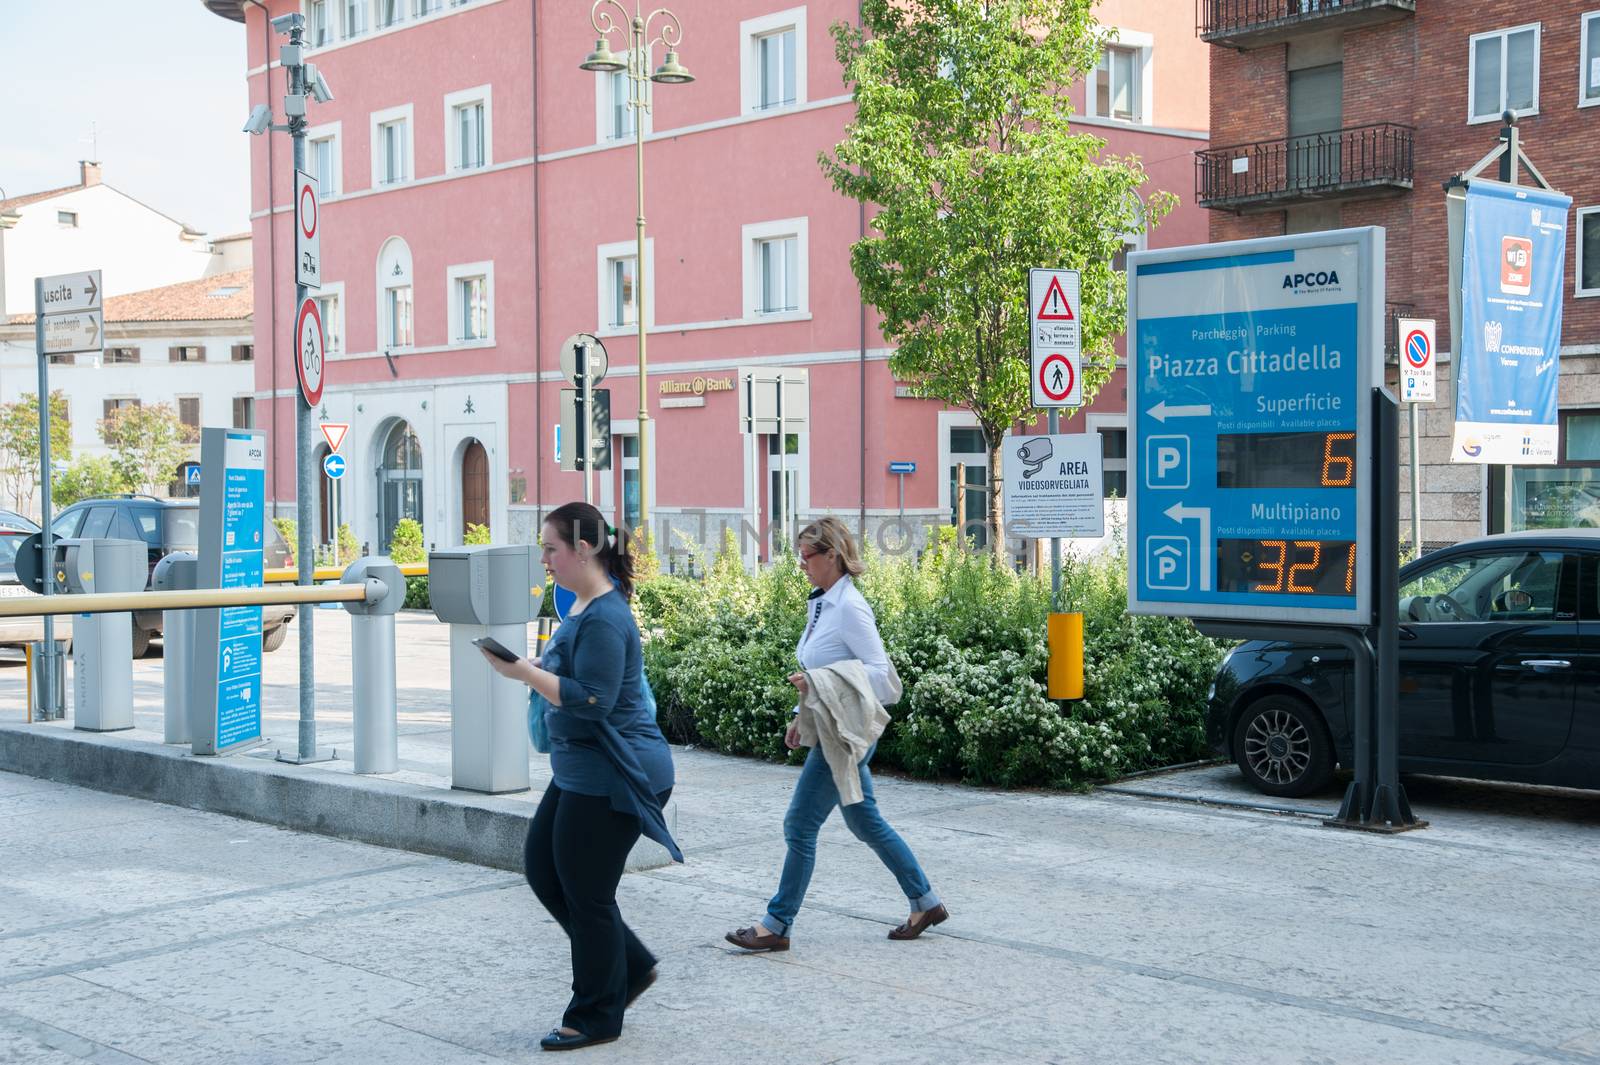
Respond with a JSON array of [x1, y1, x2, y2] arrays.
[[1206, 529, 1600, 796]]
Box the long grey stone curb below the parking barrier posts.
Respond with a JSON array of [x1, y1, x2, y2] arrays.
[[0, 724, 677, 873]]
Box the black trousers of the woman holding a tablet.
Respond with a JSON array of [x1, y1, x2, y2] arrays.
[[523, 784, 672, 1038]]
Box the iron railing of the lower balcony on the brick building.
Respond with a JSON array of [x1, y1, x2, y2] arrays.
[[1195, 122, 1414, 211]]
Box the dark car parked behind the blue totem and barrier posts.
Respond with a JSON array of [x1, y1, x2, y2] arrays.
[[50, 496, 294, 659]]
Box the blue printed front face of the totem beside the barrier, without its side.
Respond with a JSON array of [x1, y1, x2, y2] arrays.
[[216, 432, 266, 750]]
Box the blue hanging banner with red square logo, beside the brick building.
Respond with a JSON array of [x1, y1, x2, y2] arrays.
[[1450, 179, 1573, 465]]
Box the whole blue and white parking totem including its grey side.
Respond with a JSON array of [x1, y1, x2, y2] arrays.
[[192, 429, 267, 755]]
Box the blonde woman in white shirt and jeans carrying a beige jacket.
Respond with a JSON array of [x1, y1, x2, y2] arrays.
[[725, 517, 949, 950]]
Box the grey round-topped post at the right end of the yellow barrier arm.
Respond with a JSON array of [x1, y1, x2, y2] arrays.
[[341, 558, 405, 772]]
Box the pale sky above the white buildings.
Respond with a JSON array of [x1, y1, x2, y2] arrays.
[[0, 0, 250, 237]]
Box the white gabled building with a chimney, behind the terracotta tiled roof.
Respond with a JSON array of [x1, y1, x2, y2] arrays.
[[0, 162, 222, 321]]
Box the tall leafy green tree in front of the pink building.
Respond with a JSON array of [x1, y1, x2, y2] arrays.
[[821, 0, 1176, 556]]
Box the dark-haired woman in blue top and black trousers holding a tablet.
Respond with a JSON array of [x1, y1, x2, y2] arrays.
[[485, 502, 677, 1051]]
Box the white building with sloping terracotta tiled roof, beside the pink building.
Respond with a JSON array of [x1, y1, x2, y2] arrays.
[[0, 270, 256, 511]]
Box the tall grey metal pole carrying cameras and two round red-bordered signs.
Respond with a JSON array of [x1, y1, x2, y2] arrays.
[[286, 24, 326, 764]]
